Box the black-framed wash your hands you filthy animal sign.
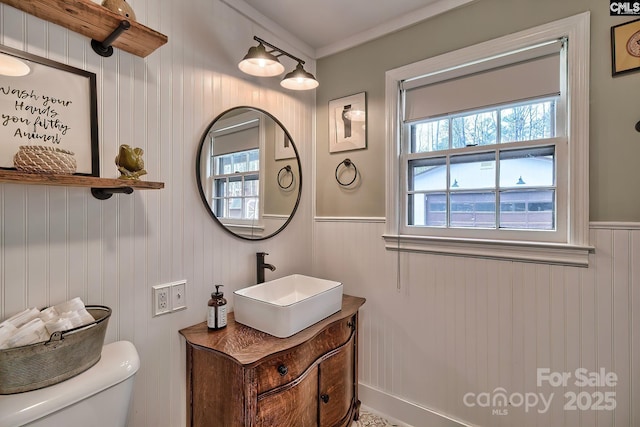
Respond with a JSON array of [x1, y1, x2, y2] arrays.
[[0, 46, 100, 176]]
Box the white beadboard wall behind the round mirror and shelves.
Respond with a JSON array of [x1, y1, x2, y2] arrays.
[[0, 0, 315, 427]]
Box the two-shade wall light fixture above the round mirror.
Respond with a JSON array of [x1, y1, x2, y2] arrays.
[[238, 36, 319, 90]]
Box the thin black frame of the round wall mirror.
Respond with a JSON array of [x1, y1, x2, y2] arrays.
[[195, 105, 302, 242]]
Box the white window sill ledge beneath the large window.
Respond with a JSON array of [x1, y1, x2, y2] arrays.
[[382, 234, 594, 267]]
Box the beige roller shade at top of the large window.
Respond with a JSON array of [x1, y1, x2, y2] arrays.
[[402, 41, 562, 122]]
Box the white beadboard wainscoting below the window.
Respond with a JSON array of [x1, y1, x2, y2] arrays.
[[313, 218, 640, 427]]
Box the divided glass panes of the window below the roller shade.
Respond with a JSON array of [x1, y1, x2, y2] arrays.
[[404, 99, 564, 230]]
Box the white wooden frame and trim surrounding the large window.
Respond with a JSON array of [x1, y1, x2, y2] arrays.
[[383, 12, 593, 266]]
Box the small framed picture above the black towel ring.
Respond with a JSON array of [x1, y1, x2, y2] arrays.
[[329, 92, 367, 153]]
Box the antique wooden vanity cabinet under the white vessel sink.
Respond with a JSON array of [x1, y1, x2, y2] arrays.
[[180, 295, 365, 427]]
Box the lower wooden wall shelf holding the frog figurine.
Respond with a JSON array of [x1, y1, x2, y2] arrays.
[[0, 170, 164, 200]]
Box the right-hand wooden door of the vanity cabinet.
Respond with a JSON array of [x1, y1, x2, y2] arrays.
[[318, 336, 355, 427]]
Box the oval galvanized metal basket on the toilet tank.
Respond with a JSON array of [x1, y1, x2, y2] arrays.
[[0, 305, 111, 394]]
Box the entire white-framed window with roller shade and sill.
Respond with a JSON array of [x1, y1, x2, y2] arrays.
[[385, 13, 591, 265]]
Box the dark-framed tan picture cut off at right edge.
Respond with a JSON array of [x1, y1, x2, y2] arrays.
[[611, 19, 640, 76]]
